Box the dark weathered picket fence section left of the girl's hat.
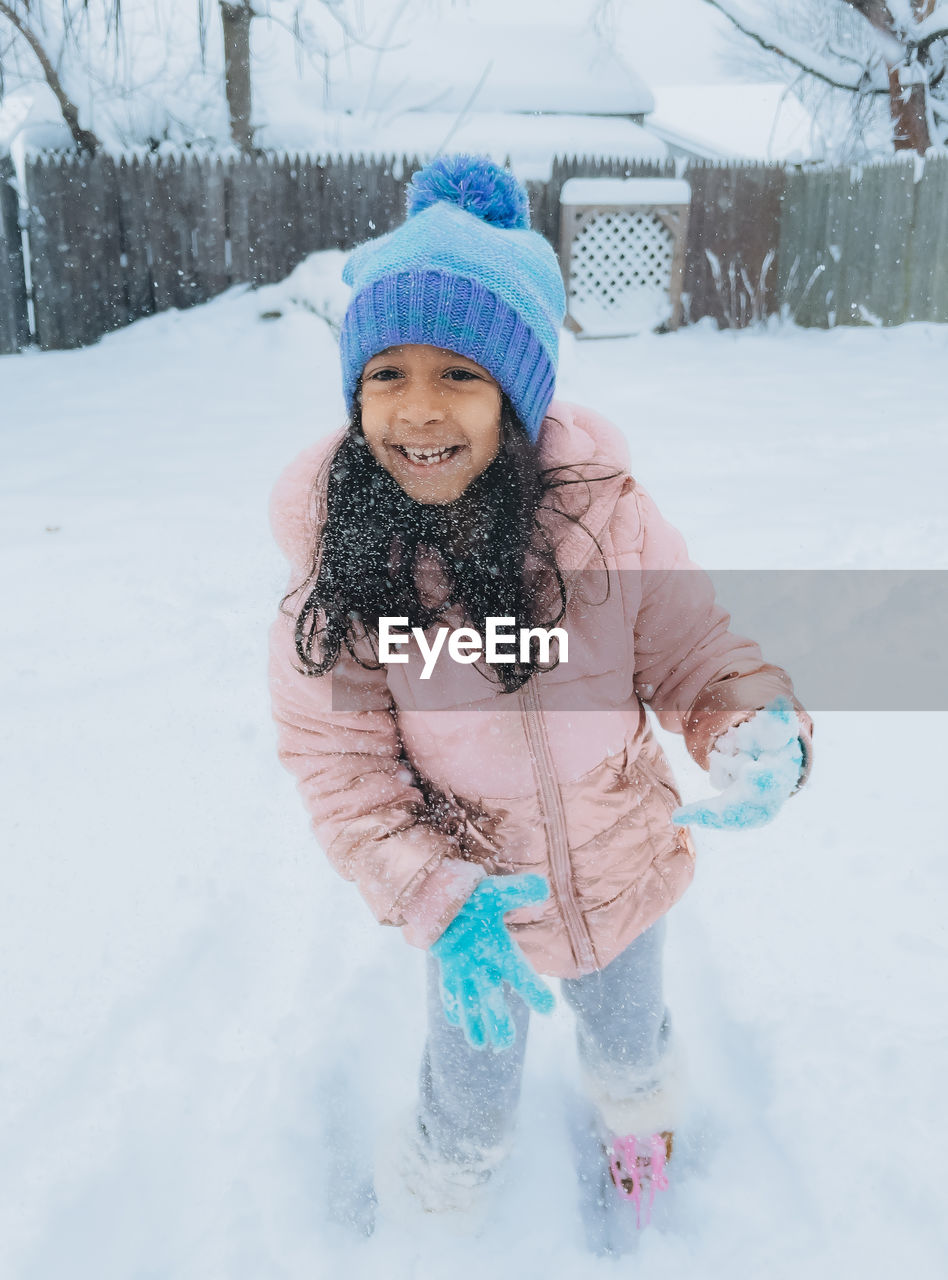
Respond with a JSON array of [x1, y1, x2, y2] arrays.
[[18, 155, 411, 349]]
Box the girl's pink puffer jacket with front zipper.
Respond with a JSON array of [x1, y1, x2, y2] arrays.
[[271, 403, 811, 978]]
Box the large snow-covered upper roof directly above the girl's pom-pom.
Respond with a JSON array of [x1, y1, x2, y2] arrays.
[[326, 20, 652, 115]]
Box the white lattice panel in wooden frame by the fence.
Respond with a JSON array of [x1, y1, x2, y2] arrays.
[[569, 211, 674, 326]]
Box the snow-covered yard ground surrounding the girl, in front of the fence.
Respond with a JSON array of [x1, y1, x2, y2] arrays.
[[0, 262, 948, 1280]]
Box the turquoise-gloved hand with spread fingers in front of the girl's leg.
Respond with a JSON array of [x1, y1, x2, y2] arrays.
[[431, 876, 554, 1051]]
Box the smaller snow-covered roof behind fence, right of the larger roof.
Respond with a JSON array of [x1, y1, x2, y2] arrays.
[[649, 82, 819, 160]]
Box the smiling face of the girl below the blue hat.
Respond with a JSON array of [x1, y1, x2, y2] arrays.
[[362, 344, 502, 506]]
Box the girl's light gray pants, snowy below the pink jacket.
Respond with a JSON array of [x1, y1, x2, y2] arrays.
[[418, 920, 670, 1165]]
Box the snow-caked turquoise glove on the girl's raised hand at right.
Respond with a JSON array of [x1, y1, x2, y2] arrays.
[[672, 698, 803, 829]]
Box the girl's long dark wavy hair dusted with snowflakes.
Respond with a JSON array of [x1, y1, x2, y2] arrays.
[[284, 396, 617, 692]]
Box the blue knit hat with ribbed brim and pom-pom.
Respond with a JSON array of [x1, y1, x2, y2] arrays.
[[340, 155, 565, 440]]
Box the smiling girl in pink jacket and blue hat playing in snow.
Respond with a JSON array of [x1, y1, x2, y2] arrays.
[[271, 156, 811, 1221]]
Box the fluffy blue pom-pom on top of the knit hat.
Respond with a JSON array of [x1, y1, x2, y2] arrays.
[[407, 155, 530, 230]]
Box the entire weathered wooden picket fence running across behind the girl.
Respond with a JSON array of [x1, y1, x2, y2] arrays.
[[0, 155, 948, 352]]
